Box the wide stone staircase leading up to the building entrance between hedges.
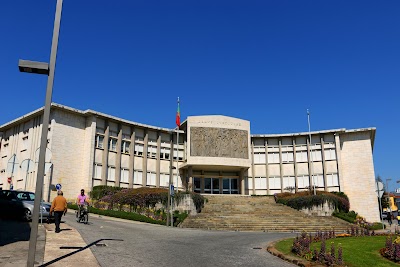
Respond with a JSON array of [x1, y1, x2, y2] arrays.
[[179, 195, 352, 232]]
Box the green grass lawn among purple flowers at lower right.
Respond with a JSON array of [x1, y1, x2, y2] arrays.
[[275, 236, 400, 267]]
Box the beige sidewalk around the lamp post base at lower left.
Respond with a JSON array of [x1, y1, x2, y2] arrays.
[[0, 221, 100, 267]]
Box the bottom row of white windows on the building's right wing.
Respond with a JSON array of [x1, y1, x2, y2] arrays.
[[247, 173, 339, 190]]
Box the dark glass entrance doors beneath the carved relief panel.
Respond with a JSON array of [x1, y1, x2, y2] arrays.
[[193, 177, 239, 194]]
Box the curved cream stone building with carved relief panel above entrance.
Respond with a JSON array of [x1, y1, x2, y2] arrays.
[[0, 103, 379, 222]]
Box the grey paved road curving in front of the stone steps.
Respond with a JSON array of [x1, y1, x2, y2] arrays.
[[64, 214, 294, 267]]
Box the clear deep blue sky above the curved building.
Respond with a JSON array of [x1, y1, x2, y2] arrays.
[[0, 0, 400, 193]]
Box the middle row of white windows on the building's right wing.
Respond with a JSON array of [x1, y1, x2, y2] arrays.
[[254, 148, 336, 164]]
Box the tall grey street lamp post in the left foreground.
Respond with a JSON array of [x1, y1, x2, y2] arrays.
[[19, 0, 63, 267]]
